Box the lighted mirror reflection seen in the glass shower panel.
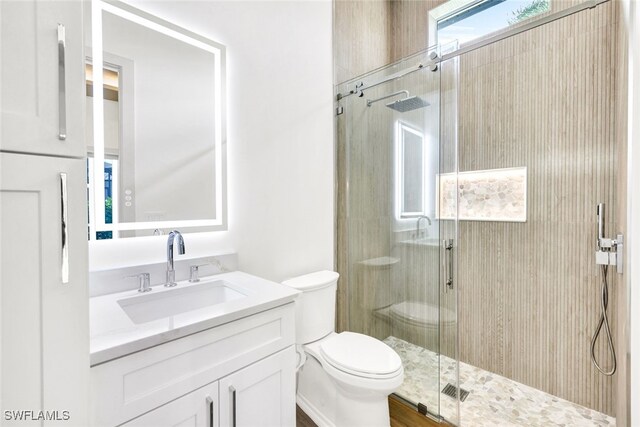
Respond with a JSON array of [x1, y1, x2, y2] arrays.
[[395, 121, 425, 218]]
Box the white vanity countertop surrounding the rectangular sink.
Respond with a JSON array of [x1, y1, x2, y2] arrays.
[[89, 271, 299, 366]]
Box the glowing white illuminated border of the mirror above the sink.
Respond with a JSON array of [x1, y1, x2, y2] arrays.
[[90, 0, 227, 237]]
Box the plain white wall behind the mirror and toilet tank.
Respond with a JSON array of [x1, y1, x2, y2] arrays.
[[90, 0, 334, 281]]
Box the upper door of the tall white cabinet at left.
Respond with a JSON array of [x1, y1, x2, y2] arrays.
[[0, 0, 86, 157]]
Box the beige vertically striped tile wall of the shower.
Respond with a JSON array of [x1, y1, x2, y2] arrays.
[[334, 0, 628, 424]]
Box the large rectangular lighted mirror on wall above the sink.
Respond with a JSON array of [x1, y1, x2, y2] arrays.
[[86, 1, 226, 240]]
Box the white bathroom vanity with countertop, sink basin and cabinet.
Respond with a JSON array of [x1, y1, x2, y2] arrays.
[[90, 272, 297, 427]]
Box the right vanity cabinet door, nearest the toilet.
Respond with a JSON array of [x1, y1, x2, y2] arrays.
[[220, 346, 296, 427]]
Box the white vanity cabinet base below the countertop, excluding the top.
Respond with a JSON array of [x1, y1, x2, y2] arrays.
[[90, 302, 296, 427]]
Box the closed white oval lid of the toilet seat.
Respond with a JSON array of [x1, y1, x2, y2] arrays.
[[320, 332, 402, 376]]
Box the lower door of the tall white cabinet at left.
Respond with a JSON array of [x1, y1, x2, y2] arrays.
[[0, 153, 89, 427]]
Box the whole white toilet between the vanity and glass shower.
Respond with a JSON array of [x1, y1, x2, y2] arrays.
[[283, 271, 404, 427]]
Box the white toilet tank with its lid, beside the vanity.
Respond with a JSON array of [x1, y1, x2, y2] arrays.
[[282, 270, 340, 344]]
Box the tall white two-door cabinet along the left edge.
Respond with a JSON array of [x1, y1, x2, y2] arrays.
[[0, 0, 89, 426]]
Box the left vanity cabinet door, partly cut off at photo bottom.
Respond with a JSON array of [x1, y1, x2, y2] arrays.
[[123, 381, 219, 427]]
